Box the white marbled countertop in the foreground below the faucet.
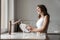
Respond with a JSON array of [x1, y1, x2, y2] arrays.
[[1, 32, 46, 39]]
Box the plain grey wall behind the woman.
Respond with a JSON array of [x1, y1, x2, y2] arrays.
[[15, 0, 60, 32]]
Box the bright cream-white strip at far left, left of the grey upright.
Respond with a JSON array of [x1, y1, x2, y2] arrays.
[[1, 0, 8, 32]]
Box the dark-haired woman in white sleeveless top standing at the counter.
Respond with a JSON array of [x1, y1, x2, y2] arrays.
[[27, 5, 50, 33]]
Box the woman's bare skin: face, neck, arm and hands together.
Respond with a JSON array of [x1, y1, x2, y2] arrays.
[[27, 7, 49, 33]]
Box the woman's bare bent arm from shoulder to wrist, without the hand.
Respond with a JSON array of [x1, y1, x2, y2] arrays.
[[30, 16, 49, 32]]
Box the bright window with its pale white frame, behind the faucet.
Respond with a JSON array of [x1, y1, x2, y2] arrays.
[[1, 0, 14, 33]]
